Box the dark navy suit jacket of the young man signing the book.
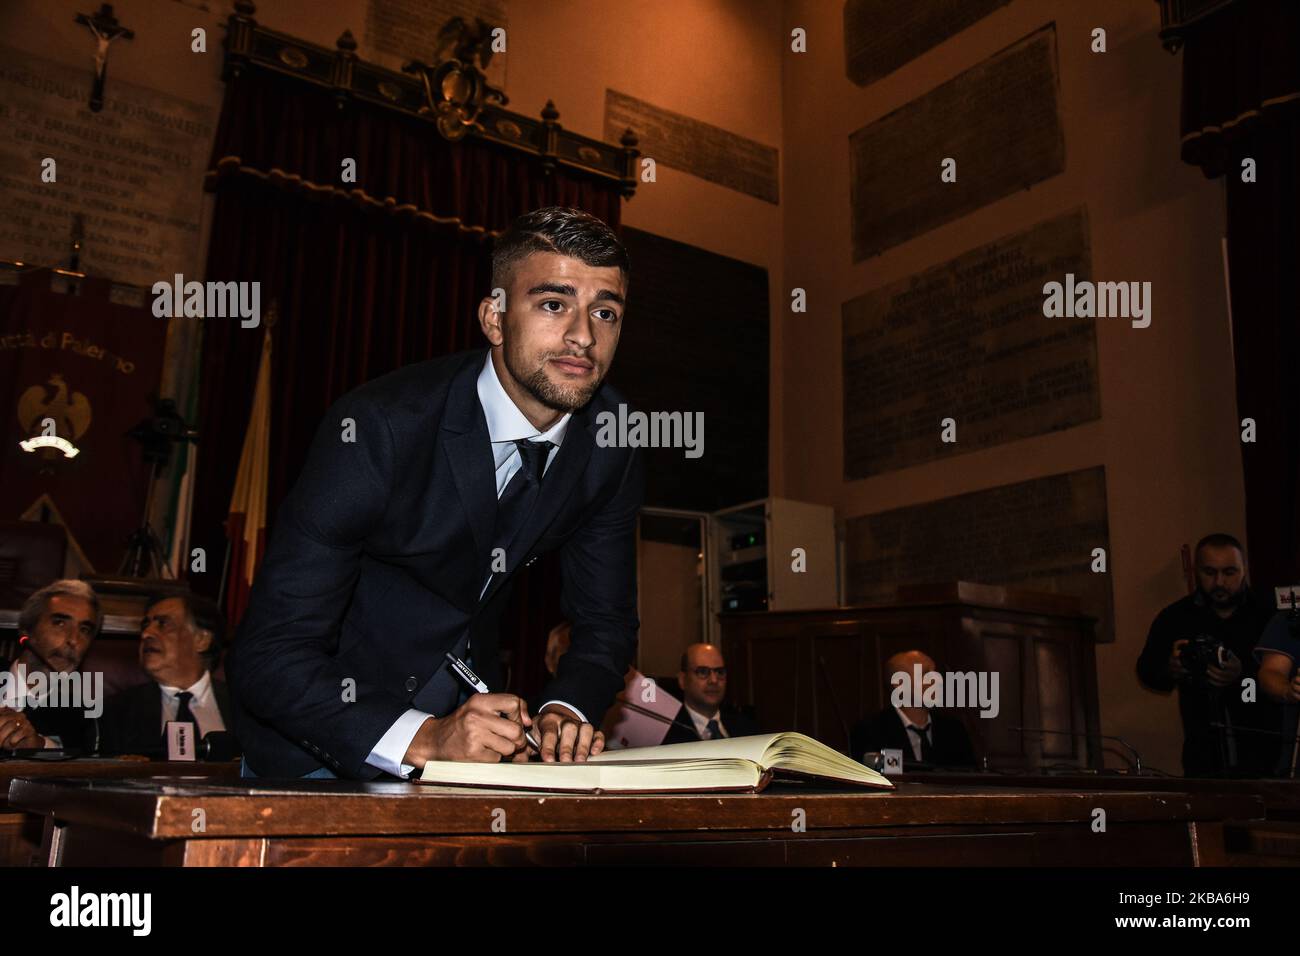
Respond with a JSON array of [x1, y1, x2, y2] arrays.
[[226, 349, 645, 779]]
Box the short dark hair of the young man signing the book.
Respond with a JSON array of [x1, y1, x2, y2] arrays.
[[491, 206, 632, 291]]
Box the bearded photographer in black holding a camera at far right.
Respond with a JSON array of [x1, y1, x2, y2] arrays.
[[1138, 535, 1282, 777]]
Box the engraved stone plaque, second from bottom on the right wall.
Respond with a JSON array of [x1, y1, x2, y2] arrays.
[[841, 208, 1101, 481]]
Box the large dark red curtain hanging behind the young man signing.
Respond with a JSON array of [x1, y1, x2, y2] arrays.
[[192, 70, 620, 693]]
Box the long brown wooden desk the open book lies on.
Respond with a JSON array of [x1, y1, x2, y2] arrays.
[[9, 778, 1264, 866]]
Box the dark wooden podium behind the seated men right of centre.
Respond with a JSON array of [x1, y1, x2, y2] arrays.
[[719, 581, 1102, 770]]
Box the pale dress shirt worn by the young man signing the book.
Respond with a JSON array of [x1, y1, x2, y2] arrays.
[[365, 351, 588, 777]]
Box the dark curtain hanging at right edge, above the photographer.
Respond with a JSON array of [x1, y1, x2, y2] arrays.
[[1182, 0, 1300, 588]]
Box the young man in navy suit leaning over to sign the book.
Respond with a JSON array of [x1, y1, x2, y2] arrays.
[[228, 207, 645, 779]]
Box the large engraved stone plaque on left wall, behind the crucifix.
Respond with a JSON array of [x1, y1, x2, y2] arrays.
[[0, 47, 213, 285]]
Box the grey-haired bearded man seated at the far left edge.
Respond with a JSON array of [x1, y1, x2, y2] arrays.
[[0, 579, 104, 752]]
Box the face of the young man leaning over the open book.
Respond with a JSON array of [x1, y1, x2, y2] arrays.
[[478, 252, 627, 424]]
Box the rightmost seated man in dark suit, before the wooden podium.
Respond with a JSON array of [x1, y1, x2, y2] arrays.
[[849, 650, 976, 770]]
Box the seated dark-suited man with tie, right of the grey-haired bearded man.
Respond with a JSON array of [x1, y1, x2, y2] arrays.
[[100, 593, 230, 757]]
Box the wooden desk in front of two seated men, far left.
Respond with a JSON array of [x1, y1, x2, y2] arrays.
[[0, 758, 239, 866]]
